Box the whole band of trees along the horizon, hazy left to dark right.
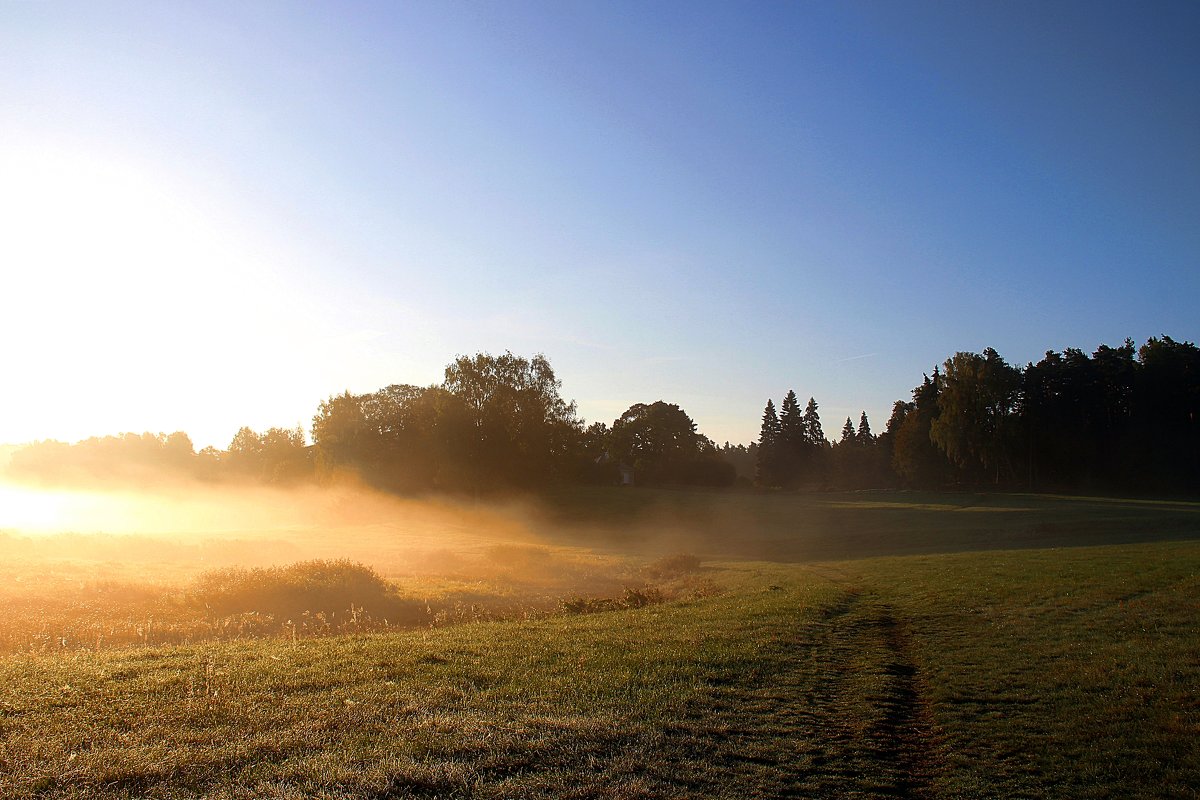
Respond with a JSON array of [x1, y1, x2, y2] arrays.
[[7, 336, 1200, 495]]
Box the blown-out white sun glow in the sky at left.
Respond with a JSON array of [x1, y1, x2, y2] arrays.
[[0, 148, 324, 445]]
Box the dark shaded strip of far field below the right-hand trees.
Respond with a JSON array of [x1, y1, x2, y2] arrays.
[[536, 488, 1200, 563]]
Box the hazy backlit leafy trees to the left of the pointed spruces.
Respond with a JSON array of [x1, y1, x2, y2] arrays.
[[7, 353, 736, 493]]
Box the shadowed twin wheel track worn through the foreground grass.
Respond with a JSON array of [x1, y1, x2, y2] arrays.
[[668, 587, 937, 798]]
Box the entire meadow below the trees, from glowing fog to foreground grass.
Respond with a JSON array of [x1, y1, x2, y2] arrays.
[[0, 483, 1200, 800]]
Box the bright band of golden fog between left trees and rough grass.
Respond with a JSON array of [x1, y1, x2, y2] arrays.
[[0, 472, 590, 592]]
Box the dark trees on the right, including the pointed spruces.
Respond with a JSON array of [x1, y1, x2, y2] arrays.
[[758, 336, 1200, 495]]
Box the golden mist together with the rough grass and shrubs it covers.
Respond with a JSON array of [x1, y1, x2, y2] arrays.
[[0, 479, 715, 652]]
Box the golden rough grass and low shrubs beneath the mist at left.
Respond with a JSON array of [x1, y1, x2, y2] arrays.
[[0, 535, 700, 654]]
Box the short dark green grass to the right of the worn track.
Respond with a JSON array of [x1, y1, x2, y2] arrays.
[[859, 543, 1200, 798]]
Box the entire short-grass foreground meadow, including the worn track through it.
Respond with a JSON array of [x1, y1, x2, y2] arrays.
[[0, 543, 1200, 798]]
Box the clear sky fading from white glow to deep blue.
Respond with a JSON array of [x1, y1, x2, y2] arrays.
[[0, 0, 1200, 447]]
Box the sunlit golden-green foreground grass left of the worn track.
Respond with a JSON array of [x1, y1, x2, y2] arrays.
[[0, 563, 822, 796]]
